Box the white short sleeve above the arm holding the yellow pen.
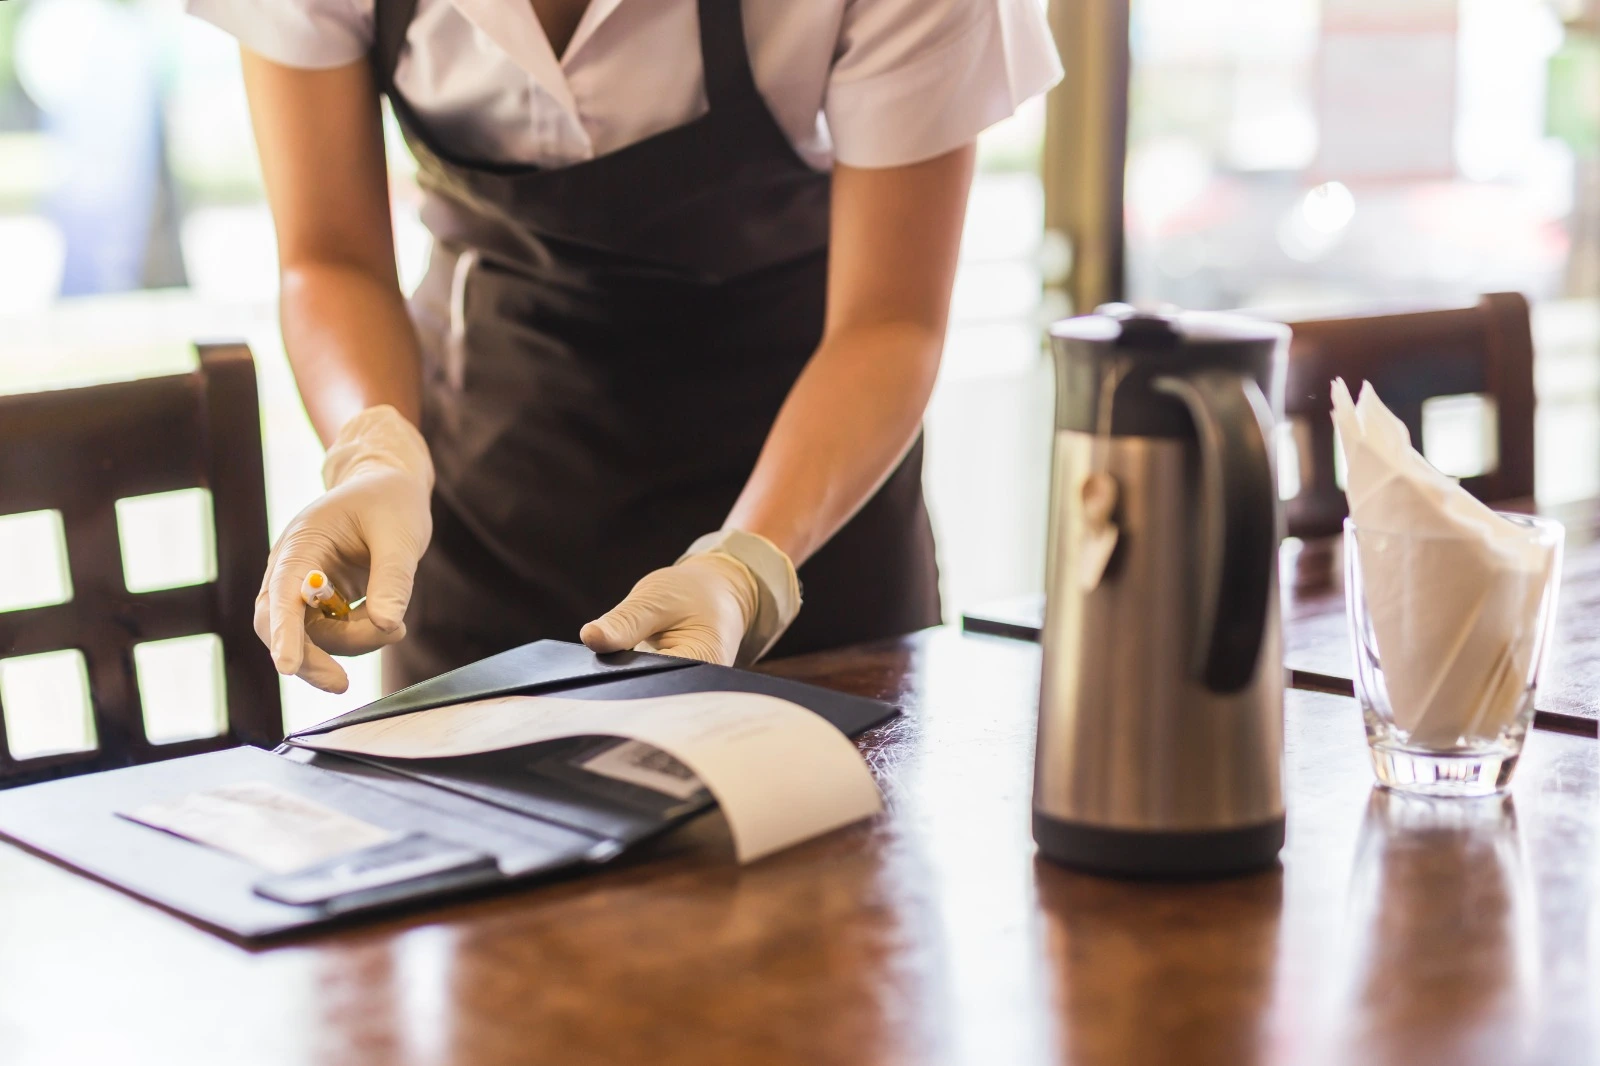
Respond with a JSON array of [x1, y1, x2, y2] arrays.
[[184, 0, 373, 69]]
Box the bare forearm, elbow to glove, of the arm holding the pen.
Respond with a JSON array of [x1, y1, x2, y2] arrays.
[[280, 262, 422, 445]]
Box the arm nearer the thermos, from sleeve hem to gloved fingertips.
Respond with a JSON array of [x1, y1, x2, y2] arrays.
[[581, 144, 974, 664]]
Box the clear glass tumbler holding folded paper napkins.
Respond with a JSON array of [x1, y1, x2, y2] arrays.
[[1344, 514, 1565, 795]]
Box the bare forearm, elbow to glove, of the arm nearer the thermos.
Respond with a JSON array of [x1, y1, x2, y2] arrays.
[[726, 322, 944, 567]]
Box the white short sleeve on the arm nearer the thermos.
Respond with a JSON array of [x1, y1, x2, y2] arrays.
[[822, 0, 1061, 166]]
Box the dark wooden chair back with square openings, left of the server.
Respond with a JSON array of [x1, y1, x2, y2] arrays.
[[0, 344, 283, 787]]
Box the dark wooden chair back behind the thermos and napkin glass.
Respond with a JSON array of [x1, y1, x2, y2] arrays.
[[1283, 293, 1534, 536]]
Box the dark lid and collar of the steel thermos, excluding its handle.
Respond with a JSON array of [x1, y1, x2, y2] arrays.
[[1050, 304, 1290, 437]]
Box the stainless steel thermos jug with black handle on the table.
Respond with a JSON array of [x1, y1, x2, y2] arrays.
[[1034, 306, 1290, 877]]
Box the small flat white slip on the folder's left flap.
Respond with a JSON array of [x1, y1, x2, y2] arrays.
[[117, 781, 400, 874]]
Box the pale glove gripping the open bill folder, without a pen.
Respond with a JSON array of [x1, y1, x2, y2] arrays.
[[579, 530, 800, 666]]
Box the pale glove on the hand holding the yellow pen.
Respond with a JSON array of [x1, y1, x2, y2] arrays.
[[256, 405, 434, 693]]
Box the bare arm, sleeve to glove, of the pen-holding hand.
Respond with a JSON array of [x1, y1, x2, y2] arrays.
[[242, 50, 422, 443]]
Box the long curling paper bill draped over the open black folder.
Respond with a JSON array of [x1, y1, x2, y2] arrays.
[[291, 691, 883, 863]]
